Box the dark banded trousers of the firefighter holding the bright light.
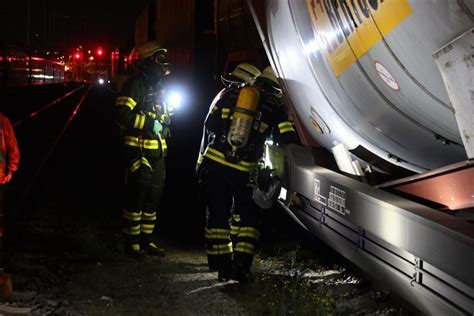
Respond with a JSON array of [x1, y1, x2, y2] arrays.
[[122, 156, 165, 250]]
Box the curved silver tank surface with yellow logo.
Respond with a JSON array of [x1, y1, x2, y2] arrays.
[[266, 0, 474, 172]]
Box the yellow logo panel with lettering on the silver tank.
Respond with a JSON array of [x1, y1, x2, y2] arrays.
[[306, 0, 412, 76]]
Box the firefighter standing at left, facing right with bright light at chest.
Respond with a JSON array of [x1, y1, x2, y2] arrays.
[[114, 41, 170, 257]]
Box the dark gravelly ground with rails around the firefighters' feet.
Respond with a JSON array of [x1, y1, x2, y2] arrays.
[[3, 87, 416, 315]]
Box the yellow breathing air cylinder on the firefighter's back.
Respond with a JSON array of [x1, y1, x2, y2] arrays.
[[227, 87, 260, 155]]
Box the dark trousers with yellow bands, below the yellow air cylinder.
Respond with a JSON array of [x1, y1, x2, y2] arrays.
[[202, 159, 260, 271]]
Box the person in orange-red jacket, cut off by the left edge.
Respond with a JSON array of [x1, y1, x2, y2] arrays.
[[0, 113, 20, 269]]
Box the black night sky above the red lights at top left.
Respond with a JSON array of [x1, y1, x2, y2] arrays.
[[0, 0, 148, 52]]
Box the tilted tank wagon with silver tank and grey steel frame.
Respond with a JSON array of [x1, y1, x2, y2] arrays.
[[247, 0, 474, 315]]
